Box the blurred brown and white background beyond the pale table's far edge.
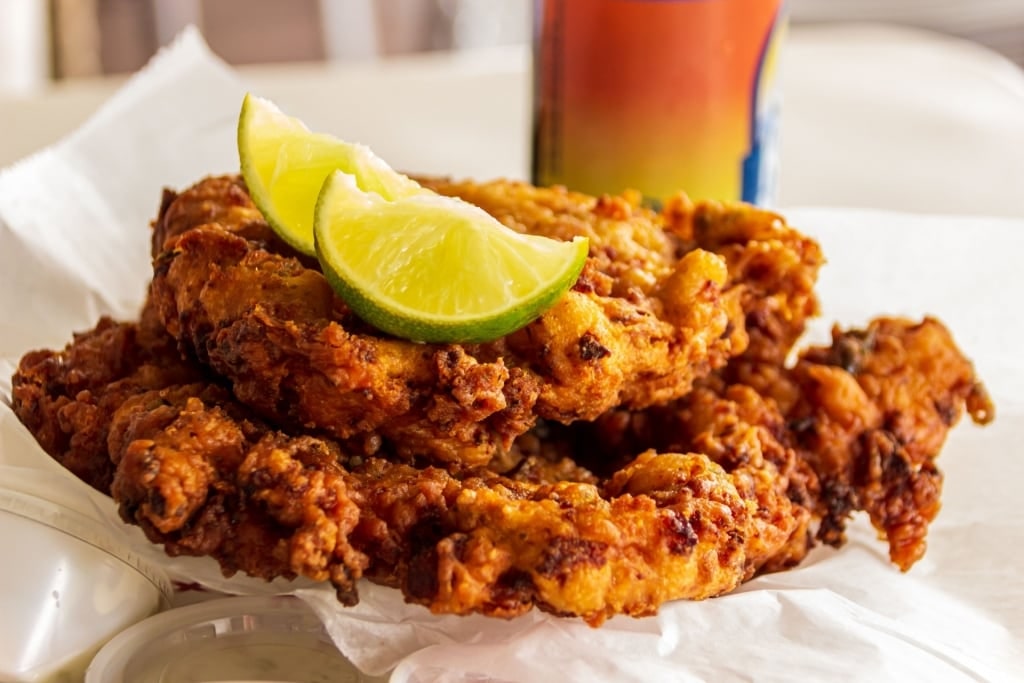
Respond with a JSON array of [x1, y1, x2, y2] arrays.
[[0, 0, 1024, 95]]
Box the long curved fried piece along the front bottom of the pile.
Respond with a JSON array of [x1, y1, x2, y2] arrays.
[[9, 313, 788, 625]]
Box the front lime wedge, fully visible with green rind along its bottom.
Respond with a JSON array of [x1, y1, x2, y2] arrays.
[[313, 172, 588, 342]]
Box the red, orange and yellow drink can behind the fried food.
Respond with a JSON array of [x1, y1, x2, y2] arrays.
[[532, 0, 785, 205]]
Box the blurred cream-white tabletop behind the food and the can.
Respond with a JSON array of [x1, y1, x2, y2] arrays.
[[0, 25, 1024, 217]]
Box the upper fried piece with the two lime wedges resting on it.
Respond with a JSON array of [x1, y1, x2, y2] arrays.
[[153, 178, 745, 465]]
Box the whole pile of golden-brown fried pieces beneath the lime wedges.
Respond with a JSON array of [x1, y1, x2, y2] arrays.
[[13, 176, 994, 626]]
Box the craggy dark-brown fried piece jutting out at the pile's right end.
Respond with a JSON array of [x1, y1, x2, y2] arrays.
[[579, 318, 994, 570]]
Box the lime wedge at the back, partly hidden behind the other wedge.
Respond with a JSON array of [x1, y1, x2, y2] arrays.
[[239, 94, 429, 256]]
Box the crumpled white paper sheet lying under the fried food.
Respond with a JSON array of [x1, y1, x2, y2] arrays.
[[0, 32, 1024, 683]]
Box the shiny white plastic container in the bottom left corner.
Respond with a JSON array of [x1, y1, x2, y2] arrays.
[[0, 485, 172, 683]]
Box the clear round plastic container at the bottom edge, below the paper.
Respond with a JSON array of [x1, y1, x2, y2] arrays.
[[85, 596, 367, 683]]
